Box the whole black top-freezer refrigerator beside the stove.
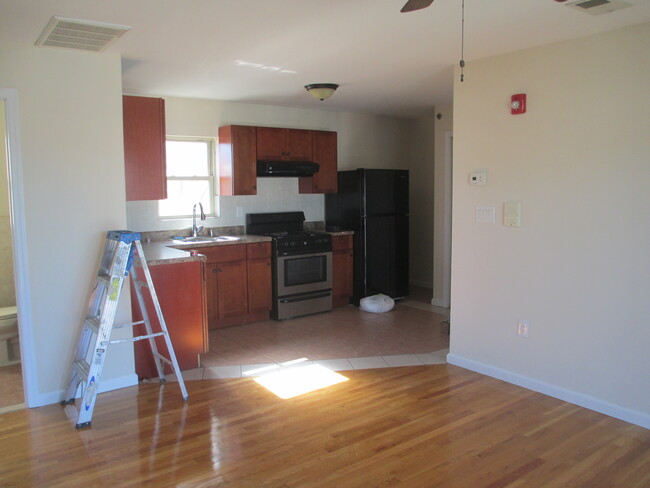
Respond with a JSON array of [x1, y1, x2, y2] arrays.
[[325, 169, 409, 304]]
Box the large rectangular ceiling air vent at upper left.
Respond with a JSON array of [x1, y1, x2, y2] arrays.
[[36, 17, 130, 52]]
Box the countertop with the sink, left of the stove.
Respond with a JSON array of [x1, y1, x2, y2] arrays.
[[142, 235, 271, 266]]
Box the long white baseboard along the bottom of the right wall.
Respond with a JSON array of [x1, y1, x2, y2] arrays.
[[447, 354, 650, 429]]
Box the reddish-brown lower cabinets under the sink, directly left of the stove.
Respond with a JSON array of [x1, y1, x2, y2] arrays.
[[196, 242, 271, 329]]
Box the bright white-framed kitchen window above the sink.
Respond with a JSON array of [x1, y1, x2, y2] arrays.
[[158, 137, 215, 218]]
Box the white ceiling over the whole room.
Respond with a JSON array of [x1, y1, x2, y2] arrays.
[[0, 0, 650, 118]]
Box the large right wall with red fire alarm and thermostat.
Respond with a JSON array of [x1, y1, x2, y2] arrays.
[[449, 24, 650, 427]]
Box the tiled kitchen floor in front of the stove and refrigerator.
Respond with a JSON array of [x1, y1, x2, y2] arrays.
[[162, 298, 449, 381]]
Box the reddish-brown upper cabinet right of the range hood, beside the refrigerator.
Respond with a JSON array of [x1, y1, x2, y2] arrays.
[[299, 130, 338, 193]]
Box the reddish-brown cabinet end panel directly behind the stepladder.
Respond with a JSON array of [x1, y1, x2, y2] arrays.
[[134, 261, 208, 378]]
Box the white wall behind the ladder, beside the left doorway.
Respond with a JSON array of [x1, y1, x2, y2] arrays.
[[0, 43, 137, 406]]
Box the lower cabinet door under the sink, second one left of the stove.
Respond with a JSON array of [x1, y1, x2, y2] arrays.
[[215, 261, 248, 319]]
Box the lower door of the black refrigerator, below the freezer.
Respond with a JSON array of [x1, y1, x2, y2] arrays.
[[364, 215, 409, 298]]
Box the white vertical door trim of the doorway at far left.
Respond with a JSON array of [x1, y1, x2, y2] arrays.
[[0, 88, 38, 407]]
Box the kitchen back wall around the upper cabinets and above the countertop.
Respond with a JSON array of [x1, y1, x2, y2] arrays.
[[127, 98, 411, 231]]
